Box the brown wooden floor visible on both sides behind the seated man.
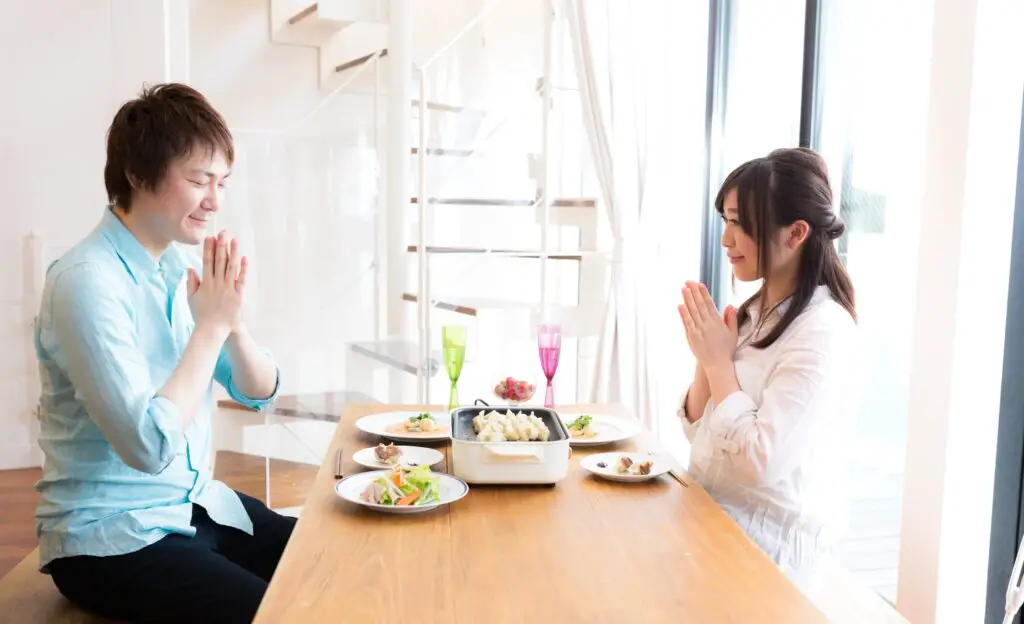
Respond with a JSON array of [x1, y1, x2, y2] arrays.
[[0, 451, 318, 577]]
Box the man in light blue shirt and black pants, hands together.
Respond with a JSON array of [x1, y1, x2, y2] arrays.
[[35, 84, 295, 623]]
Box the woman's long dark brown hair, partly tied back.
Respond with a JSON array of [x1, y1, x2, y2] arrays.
[[715, 148, 857, 348]]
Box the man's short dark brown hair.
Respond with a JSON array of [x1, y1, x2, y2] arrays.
[[103, 83, 234, 212]]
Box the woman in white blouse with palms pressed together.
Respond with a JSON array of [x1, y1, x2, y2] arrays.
[[679, 144, 857, 590]]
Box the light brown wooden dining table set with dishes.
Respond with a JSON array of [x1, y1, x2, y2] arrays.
[[256, 405, 825, 624]]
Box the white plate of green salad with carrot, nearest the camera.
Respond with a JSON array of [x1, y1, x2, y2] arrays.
[[334, 465, 469, 513]]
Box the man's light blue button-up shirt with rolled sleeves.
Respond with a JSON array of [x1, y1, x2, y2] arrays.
[[35, 208, 280, 572]]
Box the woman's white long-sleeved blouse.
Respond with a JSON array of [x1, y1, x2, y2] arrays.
[[679, 286, 859, 584]]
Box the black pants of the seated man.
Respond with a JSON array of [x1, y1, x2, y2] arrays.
[[50, 493, 295, 624]]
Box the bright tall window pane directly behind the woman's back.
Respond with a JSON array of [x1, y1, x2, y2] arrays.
[[811, 0, 932, 600]]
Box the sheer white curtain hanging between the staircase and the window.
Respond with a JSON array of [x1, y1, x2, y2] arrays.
[[564, 0, 708, 431]]
